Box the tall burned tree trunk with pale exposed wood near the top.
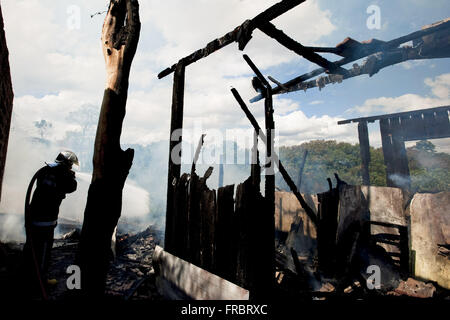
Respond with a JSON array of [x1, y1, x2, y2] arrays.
[[80, 0, 140, 296]]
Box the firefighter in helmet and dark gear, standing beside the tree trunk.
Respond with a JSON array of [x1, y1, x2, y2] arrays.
[[24, 151, 79, 299]]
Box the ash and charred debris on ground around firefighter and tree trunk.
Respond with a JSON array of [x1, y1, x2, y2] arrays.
[[0, 227, 163, 300]]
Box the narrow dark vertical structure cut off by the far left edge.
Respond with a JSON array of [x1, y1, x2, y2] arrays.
[[0, 7, 14, 202]]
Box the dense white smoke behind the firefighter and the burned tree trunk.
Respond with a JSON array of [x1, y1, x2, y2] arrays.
[[0, 130, 150, 242]]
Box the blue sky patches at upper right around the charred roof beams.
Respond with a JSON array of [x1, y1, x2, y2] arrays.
[[269, 0, 450, 116]]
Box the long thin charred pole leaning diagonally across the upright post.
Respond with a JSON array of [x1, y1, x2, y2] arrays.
[[231, 88, 317, 225]]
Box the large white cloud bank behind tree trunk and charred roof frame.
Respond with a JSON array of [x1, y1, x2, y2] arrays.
[[2, 0, 335, 148]]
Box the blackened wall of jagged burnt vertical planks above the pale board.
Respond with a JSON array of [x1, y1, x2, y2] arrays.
[[167, 164, 274, 298]]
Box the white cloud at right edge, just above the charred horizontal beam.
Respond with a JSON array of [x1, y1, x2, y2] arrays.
[[347, 73, 450, 115]]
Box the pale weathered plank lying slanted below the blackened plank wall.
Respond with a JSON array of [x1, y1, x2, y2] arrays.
[[153, 246, 249, 300]]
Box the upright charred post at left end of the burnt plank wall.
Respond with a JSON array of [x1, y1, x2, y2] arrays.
[[164, 60, 185, 253]]
